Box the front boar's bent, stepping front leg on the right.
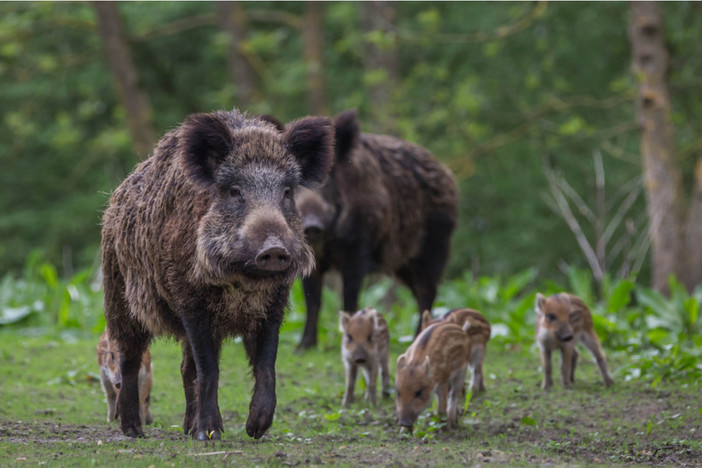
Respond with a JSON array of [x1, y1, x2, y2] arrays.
[[244, 296, 289, 439]]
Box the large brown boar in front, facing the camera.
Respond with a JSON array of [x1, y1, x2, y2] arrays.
[[102, 111, 334, 440]]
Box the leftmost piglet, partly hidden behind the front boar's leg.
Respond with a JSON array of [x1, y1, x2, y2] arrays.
[[97, 330, 154, 424]]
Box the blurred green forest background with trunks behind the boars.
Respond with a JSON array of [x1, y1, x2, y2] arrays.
[[0, 2, 702, 290]]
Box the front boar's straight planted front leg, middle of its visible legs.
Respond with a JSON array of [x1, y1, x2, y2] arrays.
[[181, 314, 224, 440]]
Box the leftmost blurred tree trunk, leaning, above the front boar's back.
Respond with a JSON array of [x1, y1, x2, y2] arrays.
[[93, 2, 156, 159]]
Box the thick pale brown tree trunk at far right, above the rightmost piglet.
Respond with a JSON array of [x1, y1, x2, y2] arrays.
[[629, 2, 684, 292]]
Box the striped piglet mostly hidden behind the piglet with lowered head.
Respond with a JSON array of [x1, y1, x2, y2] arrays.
[[422, 309, 490, 394]]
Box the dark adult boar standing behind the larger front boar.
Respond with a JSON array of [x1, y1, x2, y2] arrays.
[[295, 111, 458, 348]]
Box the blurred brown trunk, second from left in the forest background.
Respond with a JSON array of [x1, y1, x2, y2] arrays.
[[216, 2, 256, 108]]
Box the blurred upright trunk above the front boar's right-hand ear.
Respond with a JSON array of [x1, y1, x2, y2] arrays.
[[302, 2, 327, 115]]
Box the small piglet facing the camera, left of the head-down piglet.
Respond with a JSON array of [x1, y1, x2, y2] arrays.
[[339, 308, 390, 406]]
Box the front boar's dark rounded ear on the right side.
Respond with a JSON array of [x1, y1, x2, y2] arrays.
[[283, 117, 334, 188]]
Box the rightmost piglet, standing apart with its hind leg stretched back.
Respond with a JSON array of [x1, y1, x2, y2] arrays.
[[536, 293, 614, 389]]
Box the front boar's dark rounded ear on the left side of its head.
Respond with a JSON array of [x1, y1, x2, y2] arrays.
[[178, 114, 234, 188]]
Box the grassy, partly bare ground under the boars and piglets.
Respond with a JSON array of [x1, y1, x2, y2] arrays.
[[0, 326, 702, 467]]
